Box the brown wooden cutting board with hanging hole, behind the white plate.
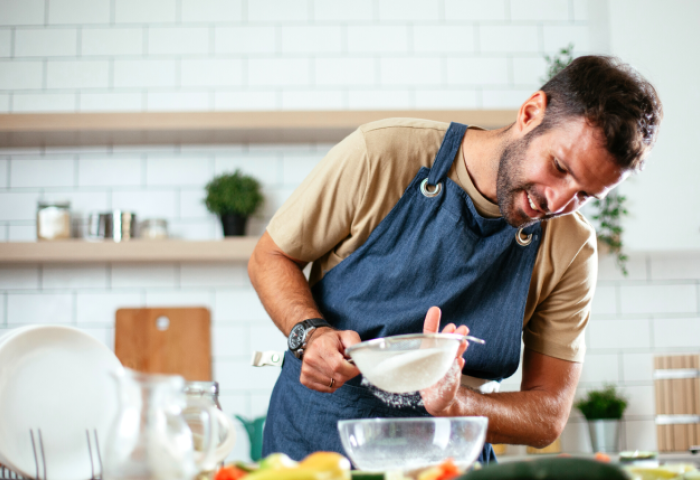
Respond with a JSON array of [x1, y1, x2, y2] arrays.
[[114, 307, 211, 381]]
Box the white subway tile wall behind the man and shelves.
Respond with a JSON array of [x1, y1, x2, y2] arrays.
[[0, 0, 700, 458]]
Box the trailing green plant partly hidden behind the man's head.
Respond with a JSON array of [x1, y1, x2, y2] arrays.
[[542, 43, 627, 276]]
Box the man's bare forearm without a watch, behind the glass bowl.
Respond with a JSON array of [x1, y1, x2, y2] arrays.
[[448, 387, 571, 448]]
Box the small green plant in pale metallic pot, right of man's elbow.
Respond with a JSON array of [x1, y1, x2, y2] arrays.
[[576, 385, 627, 452]]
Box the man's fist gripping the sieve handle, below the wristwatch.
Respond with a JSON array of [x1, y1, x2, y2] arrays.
[[299, 327, 360, 393]]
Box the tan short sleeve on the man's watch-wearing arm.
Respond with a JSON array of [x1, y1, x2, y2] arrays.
[[267, 130, 368, 262]]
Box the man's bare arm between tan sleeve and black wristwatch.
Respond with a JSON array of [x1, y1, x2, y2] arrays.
[[248, 232, 321, 335]]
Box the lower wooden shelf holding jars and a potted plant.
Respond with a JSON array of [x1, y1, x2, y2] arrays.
[[0, 237, 258, 264]]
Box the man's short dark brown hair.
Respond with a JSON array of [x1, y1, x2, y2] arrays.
[[533, 55, 663, 170]]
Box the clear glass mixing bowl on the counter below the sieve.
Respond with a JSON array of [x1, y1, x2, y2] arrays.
[[338, 417, 488, 472]]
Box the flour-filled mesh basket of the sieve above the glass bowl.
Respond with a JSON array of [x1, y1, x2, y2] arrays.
[[345, 333, 464, 393]]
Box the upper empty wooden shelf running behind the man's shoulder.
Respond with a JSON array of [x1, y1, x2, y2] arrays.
[[0, 110, 517, 148]]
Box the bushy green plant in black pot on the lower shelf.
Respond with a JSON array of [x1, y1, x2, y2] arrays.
[[204, 170, 263, 237]]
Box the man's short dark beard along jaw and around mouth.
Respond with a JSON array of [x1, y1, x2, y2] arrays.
[[496, 131, 551, 228]]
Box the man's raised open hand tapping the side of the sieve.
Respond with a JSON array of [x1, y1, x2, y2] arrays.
[[420, 307, 469, 417]]
